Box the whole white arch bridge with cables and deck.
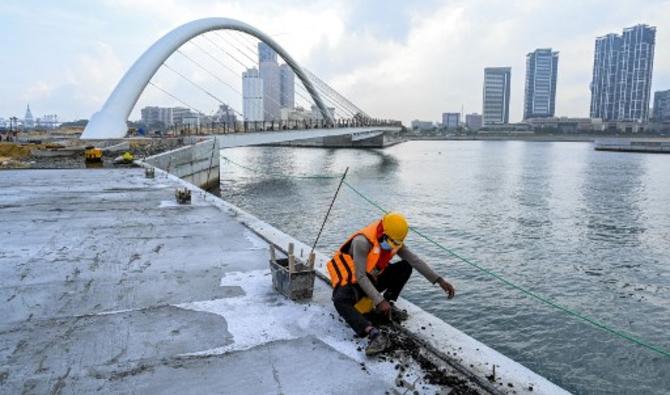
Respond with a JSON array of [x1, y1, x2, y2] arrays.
[[81, 18, 402, 146]]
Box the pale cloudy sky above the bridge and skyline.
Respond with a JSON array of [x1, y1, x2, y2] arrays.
[[0, 0, 670, 124]]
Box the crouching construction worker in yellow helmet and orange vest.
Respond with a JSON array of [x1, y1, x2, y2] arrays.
[[326, 213, 455, 355]]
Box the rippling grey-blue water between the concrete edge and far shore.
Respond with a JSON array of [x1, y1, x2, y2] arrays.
[[221, 141, 670, 394]]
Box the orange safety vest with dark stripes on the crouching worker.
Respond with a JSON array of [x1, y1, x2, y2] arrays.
[[326, 220, 398, 288]]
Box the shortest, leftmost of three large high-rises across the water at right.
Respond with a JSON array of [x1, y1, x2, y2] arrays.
[[483, 67, 512, 125]]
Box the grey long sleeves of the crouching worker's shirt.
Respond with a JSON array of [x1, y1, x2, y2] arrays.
[[349, 235, 440, 306]]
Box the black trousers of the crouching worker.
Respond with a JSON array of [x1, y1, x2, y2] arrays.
[[333, 261, 412, 336]]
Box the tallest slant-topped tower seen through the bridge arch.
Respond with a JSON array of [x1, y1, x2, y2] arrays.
[[258, 41, 281, 121]]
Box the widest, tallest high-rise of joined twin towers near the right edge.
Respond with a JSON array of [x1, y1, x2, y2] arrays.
[[591, 25, 656, 122]]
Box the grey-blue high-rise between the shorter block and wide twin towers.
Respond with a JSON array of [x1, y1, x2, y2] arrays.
[[523, 48, 558, 119]]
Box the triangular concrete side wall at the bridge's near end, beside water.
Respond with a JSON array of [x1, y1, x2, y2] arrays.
[[144, 138, 220, 189]]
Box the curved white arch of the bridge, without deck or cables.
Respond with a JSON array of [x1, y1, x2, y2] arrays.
[[81, 18, 334, 139]]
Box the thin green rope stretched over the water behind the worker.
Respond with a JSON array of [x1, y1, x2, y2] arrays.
[[222, 156, 670, 358]]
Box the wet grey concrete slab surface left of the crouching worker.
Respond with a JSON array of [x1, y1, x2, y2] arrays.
[[0, 169, 452, 394]]
